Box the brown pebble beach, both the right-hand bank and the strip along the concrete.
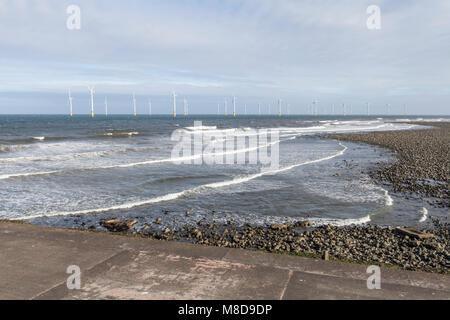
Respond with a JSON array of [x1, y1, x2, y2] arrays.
[[92, 123, 450, 273]]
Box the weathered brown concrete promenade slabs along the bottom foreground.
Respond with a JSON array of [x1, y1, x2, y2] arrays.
[[0, 222, 450, 299]]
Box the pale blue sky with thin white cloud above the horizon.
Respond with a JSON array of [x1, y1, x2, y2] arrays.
[[0, 0, 450, 115]]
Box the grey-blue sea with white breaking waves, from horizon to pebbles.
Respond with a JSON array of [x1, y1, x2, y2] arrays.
[[0, 115, 448, 228]]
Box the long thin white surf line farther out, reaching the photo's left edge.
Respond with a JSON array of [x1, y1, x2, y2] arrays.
[[0, 137, 296, 180]]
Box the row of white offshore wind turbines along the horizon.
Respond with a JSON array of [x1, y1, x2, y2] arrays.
[[69, 87, 408, 118]]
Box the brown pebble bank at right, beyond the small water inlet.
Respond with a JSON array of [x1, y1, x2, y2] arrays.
[[326, 122, 450, 208]]
